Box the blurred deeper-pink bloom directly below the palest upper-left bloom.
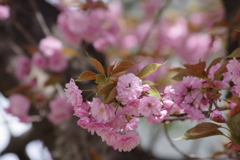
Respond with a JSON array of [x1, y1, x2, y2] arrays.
[[48, 52, 68, 72]]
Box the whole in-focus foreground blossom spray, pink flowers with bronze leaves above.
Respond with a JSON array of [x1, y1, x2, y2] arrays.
[[65, 50, 240, 151]]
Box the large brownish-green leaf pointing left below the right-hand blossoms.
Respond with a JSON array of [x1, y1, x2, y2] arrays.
[[175, 122, 224, 140]]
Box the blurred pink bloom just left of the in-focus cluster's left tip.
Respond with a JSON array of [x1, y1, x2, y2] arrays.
[[48, 96, 72, 124]]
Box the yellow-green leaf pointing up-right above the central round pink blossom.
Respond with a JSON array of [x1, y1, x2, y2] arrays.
[[136, 63, 163, 79]]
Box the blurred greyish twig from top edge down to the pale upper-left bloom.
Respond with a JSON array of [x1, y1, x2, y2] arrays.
[[29, 0, 51, 36]]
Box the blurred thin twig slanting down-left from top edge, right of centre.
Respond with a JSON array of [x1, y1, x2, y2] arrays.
[[135, 0, 171, 55]]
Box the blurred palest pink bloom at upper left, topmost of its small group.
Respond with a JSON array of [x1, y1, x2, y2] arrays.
[[39, 36, 63, 57]]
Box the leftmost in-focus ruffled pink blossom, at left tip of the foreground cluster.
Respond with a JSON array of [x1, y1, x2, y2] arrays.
[[64, 78, 83, 107]]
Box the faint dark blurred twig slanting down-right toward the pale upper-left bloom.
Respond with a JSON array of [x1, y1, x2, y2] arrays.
[[10, 18, 37, 46]]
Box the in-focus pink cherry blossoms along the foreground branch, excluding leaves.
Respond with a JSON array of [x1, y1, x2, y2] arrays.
[[65, 55, 240, 151]]
